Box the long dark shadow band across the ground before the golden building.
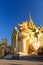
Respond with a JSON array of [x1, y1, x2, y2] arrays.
[[3, 56, 43, 62]]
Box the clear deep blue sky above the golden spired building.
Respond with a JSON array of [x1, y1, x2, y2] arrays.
[[0, 0, 43, 44]]
